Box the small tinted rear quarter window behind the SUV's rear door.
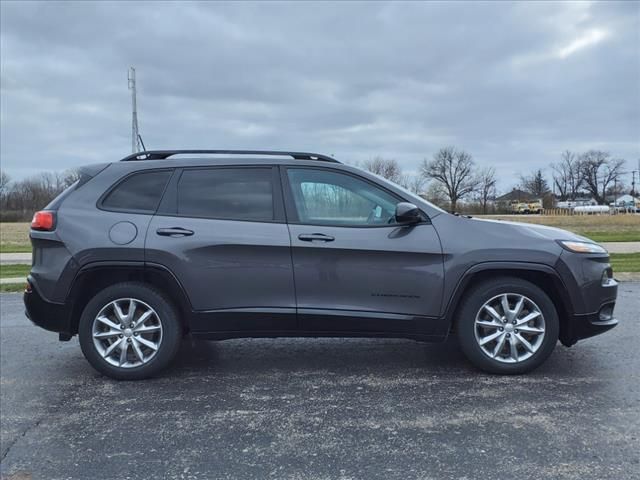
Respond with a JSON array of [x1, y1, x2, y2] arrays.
[[102, 170, 172, 213]]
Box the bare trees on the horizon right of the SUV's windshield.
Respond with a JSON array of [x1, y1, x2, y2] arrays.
[[363, 146, 637, 213]]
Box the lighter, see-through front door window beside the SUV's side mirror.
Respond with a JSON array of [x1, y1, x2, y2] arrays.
[[287, 168, 400, 226]]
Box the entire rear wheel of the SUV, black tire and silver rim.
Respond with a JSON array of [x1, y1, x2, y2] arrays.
[[78, 282, 182, 380]]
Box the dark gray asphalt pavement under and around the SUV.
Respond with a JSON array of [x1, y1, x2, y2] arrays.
[[0, 283, 640, 480]]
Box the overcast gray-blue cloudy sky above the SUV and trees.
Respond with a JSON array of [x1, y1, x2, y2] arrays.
[[0, 1, 640, 190]]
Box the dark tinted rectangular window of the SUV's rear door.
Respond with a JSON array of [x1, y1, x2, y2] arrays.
[[177, 168, 274, 221]]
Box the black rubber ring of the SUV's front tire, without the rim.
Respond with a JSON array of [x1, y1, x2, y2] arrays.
[[456, 278, 559, 374]]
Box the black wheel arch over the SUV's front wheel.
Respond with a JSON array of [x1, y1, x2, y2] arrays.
[[445, 262, 575, 346]]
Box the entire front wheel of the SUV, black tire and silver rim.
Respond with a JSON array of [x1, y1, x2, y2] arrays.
[[456, 277, 560, 375]]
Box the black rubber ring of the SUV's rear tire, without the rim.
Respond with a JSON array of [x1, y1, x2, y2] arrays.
[[78, 283, 182, 380]]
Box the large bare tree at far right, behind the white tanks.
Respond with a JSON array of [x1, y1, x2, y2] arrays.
[[580, 150, 624, 205]]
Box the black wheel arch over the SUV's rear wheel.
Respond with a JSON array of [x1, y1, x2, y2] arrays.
[[67, 262, 193, 334]]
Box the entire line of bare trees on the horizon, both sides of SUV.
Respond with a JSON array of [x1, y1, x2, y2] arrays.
[[0, 146, 637, 222]]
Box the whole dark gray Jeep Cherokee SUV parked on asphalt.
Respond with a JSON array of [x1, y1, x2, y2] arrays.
[[24, 150, 617, 379]]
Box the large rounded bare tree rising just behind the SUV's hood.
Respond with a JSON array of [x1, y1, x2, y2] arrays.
[[421, 147, 474, 211]]
